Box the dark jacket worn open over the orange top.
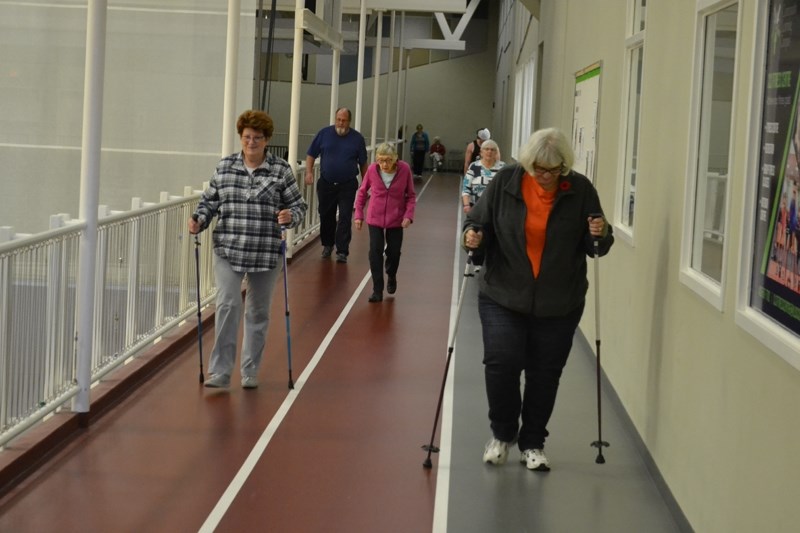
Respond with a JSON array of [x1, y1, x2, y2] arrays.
[[464, 164, 614, 317]]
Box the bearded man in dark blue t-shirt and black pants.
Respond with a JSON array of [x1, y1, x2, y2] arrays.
[[305, 107, 367, 263]]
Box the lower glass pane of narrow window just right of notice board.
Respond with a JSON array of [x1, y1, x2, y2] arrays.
[[621, 46, 643, 226]]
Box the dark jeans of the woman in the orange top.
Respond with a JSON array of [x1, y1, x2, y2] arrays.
[[478, 294, 583, 451]]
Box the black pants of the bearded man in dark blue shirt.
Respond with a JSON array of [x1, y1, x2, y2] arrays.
[[317, 178, 358, 255]]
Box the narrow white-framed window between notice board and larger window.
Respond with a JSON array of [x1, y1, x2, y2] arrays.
[[617, 0, 647, 239]]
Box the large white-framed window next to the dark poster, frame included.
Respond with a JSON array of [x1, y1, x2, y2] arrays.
[[681, 2, 739, 309]]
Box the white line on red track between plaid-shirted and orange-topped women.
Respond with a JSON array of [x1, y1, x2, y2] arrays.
[[198, 175, 438, 533]]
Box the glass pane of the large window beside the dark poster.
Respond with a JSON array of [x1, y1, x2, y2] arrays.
[[691, 5, 738, 282]]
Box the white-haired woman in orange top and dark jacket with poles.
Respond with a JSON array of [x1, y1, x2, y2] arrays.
[[463, 128, 614, 471]]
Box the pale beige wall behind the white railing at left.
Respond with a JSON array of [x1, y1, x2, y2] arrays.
[[0, 0, 255, 233]]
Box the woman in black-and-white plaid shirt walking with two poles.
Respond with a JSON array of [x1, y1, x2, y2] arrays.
[[188, 110, 306, 389]]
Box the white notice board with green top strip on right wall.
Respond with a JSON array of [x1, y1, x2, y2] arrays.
[[572, 62, 601, 183]]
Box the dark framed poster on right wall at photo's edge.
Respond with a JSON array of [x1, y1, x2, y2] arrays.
[[750, 0, 800, 335]]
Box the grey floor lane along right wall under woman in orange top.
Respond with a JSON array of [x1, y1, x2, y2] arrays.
[[447, 260, 687, 533]]
